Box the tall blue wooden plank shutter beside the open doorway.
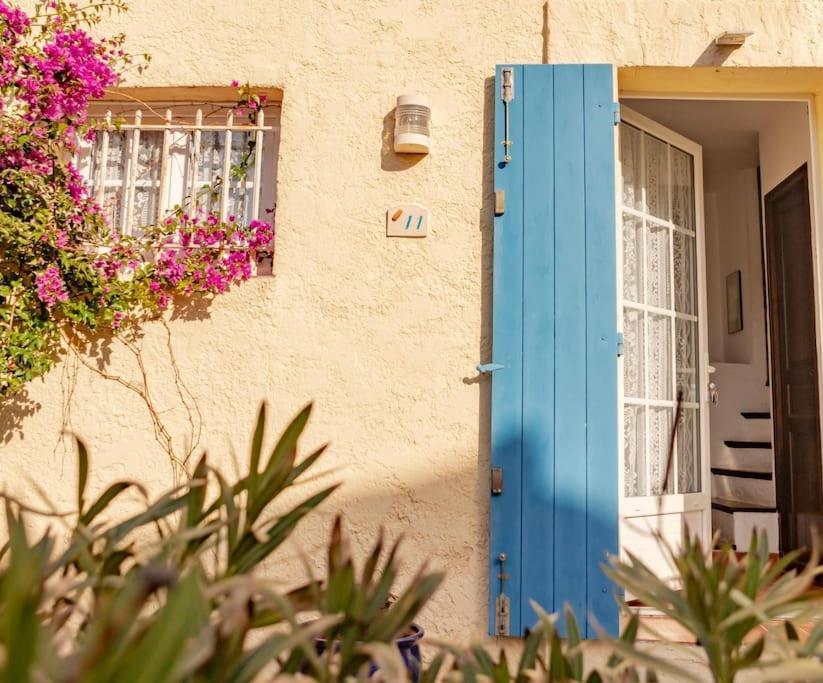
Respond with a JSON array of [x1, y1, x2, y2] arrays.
[[489, 64, 618, 637]]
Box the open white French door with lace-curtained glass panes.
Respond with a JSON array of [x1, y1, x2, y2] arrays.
[[618, 106, 711, 576]]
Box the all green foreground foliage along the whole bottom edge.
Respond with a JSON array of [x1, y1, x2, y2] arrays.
[[0, 407, 823, 683]]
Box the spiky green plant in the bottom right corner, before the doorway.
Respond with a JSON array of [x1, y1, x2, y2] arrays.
[[606, 532, 823, 683]]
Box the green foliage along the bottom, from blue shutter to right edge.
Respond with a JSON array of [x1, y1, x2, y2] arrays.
[[424, 534, 823, 683]]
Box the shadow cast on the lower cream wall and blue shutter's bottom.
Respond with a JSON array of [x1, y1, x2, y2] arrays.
[[310, 436, 619, 642]]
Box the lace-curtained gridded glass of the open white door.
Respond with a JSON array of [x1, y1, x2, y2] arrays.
[[620, 122, 702, 497]]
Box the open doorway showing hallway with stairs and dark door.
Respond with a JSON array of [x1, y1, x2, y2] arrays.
[[622, 98, 823, 552]]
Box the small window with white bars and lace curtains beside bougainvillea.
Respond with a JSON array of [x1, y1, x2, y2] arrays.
[[75, 101, 280, 235]]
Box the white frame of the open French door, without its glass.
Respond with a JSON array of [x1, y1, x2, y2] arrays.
[[616, 106, 711, 568]]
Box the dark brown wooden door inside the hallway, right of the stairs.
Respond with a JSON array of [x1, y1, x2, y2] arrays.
[[765, 165, 823, 553]]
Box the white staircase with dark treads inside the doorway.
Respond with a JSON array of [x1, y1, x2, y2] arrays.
[[711, 411, 778, 553]]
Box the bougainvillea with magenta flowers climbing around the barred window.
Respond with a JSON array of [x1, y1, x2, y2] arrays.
[[0, 0, 274, 399]]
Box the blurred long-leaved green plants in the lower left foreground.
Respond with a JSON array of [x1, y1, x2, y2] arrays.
[[0, 407, 441, 683]]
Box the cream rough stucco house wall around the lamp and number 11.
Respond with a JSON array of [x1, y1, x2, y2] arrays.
[[6, 0, 823, 639]]
